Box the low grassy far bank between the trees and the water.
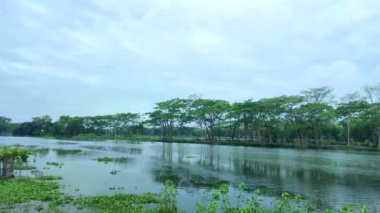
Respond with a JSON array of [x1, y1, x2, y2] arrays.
[[52, 135, 380, 152]]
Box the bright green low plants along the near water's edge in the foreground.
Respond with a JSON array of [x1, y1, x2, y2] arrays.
[[0, 177, 371, 213]]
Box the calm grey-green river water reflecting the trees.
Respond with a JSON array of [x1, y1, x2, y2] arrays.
[[0, 137, 380, 212]]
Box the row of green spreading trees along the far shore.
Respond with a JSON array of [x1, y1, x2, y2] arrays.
[[0, 83, 380, 148]]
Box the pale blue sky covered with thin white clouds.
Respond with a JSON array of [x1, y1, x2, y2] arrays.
[[0, 0, 380, 121]]
